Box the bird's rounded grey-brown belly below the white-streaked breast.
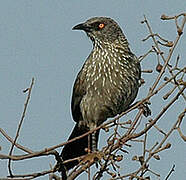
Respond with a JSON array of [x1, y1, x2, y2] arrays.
[[80, 75, 138, 127]]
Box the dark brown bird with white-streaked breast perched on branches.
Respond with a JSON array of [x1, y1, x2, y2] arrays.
[[59, 17, 141, 174]]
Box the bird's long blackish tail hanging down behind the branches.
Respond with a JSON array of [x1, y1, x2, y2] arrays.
[[59, 124, 99, 171]]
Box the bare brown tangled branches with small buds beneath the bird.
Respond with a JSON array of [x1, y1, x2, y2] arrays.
[[0, 13, 186, 180]]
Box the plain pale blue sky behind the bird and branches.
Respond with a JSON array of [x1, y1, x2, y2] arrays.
[[0, 0, 186, 180]]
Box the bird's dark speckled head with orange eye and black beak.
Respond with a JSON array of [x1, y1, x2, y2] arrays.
[[72, 17, 124, 43]]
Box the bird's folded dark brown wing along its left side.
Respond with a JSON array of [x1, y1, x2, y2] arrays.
[[71, 71, 86, 122]]
